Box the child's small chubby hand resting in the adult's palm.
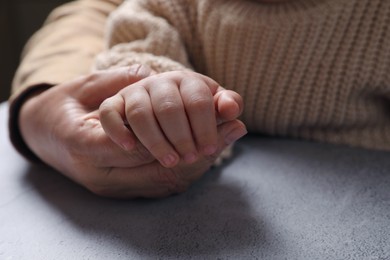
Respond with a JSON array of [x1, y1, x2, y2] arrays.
[[100, 71, 242, 167]]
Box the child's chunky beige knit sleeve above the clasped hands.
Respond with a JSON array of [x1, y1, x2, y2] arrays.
[[95, 0, 192, 72]]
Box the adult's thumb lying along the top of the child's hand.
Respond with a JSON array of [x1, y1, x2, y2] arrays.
[[73, 64, 156, 109]]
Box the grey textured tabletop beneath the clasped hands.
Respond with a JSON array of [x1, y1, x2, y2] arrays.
[[0, 103, 390, 260]]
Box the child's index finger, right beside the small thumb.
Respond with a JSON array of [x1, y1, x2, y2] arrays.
[[180, 77, 217, 155]]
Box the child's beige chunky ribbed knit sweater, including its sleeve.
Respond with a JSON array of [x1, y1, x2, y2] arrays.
[[9, 0, 390, 160]]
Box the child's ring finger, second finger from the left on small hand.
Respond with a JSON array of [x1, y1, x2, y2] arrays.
[[125, 85, 179, 167]]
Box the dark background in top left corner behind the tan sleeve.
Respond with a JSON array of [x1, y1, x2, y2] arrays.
[[0, 0, 69, 102]]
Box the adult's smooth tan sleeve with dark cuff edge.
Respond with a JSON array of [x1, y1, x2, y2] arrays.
[[9, 0, 123, 160]]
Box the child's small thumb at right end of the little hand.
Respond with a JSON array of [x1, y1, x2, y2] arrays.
[[214, 87, 243, 124]]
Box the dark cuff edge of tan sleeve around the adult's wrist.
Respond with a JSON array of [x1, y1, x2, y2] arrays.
[[8, 84, 52, 163]]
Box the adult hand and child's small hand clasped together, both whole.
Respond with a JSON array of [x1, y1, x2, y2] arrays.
[[19, 65, 246, 198]]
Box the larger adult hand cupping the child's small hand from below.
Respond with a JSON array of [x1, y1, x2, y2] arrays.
[[19, 66, 246, 198]]
